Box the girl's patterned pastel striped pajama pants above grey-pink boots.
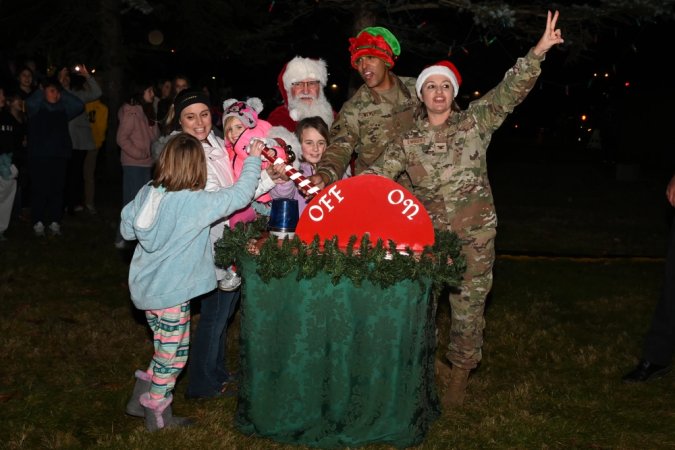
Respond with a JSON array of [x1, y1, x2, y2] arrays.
[[145, 301, 190, 399]]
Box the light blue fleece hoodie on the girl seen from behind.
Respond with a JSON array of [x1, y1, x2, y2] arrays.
[[120, 156, 260, 310]]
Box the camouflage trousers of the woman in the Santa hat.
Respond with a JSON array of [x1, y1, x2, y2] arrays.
[[446, 228, 496, 369]]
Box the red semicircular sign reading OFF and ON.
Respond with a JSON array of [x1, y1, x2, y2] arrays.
[[295, 175, 434, 252]]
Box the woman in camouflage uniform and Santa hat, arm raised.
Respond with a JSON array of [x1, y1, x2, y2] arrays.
[[365, 11, 563, 408]]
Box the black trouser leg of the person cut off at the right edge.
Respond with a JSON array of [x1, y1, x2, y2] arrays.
[[642, 214, 675, 366]]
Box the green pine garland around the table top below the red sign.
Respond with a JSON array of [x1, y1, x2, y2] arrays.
[[215, 217, 466, 292]]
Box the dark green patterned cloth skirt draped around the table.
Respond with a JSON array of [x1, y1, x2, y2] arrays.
[[236, 255, 440, 448]]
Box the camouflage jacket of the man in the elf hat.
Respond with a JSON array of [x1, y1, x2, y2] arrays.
[[317, 72, 419, 183]]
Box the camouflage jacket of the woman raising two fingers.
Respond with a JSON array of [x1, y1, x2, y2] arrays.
[[366, 50, 543, 236]]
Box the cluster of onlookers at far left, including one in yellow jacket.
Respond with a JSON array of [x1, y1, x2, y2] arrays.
[[0, 61, 108, 239]]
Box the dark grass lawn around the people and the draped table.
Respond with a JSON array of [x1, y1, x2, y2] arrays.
[[0, 150, 675, 450]]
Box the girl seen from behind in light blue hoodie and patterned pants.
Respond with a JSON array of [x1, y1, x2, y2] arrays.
[[120, 133, 263, 431]]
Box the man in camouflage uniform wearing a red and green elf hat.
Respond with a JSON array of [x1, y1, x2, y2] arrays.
[[310, 27, 419, 188]]
